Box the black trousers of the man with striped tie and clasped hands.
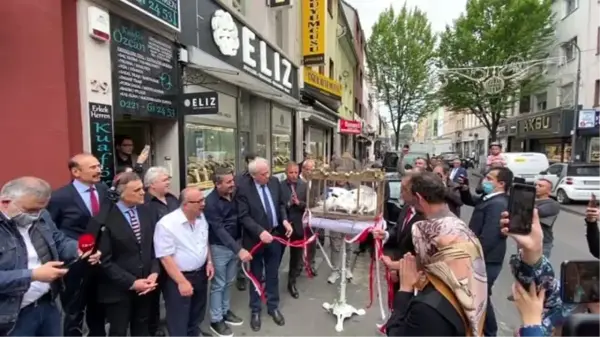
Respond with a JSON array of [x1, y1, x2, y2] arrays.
[[106, 290, 150, 337]]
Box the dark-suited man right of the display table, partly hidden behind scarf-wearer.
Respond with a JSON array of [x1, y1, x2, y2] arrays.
[[373, 173, 425, 291]]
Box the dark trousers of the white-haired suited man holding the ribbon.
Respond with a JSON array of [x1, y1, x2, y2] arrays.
[[248, 241, 284, 313]]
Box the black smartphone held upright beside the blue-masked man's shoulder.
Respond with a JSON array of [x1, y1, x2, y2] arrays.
[[508, 183, 535, 234]]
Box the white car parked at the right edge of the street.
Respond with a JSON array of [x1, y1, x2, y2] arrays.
[[535, 163, 600, 204]]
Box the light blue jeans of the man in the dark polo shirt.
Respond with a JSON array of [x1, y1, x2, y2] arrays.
[[210, 245, 238, 323]]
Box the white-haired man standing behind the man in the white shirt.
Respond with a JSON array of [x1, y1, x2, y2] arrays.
[[144, 166, 179, 337]]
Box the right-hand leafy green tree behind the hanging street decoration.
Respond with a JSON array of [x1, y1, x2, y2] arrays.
[[438, 0, 555, 141]]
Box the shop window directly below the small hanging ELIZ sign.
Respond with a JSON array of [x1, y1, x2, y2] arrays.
[[184, 123, 236, 189]]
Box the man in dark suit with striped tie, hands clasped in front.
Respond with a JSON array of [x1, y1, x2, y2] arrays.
[[93, 172, 160, 337]]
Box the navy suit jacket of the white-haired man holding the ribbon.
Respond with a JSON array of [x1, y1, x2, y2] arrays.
[[234, 176, 289, 249]]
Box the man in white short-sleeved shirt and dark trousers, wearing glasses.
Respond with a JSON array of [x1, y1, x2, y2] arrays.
[[154, 188, 214, 337]]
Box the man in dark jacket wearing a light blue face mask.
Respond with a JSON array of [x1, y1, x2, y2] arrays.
[[460, 167, 513, 337]]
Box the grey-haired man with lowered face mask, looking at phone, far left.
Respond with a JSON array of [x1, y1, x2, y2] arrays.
[[0, 177, 100, 337]]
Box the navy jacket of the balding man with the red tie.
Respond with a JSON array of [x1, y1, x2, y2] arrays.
[[47, 182, 110, 240]]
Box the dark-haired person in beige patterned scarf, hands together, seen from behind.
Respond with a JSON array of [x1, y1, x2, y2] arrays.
[[383, 172, 488, 337]]
